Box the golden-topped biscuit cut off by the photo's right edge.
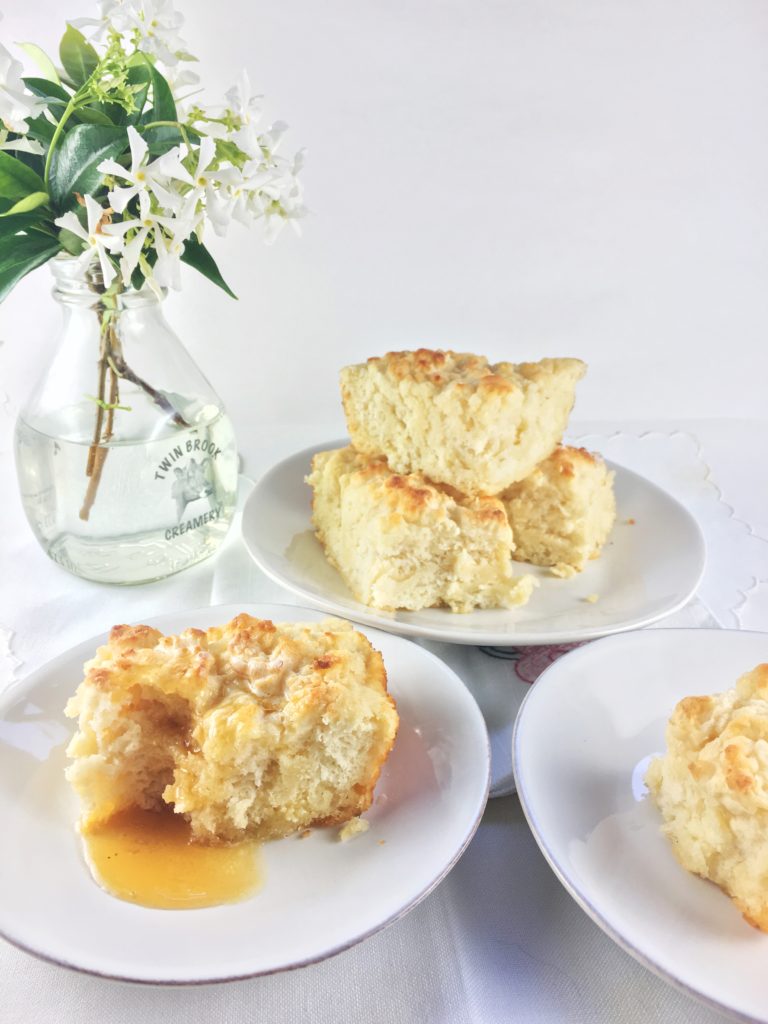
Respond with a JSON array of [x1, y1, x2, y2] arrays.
[[645, 665, 768, 931]]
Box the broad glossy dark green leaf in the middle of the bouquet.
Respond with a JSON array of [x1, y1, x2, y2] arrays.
[[48, 125, 128, 212]]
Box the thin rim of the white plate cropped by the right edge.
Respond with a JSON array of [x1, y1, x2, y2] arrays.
[[512, 626, 768, 1024]]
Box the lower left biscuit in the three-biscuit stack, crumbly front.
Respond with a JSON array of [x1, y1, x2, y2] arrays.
[[307, 446, 534, 611]]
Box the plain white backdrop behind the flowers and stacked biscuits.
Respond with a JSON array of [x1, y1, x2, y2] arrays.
[[0, 0, 768, 436]]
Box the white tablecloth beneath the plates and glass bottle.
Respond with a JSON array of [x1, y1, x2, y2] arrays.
[[0, 411, 768, 1024]]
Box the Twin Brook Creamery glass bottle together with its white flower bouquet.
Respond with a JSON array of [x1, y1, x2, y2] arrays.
[[6, 0, 303, 583]]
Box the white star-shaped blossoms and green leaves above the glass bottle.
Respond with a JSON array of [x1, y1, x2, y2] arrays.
[[0, 0, 303, 300]]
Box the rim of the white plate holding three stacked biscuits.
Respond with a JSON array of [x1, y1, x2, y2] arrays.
[[241, 438, 708, 647]]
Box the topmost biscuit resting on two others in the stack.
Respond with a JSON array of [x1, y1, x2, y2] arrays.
[[341, 348, 586, 495]]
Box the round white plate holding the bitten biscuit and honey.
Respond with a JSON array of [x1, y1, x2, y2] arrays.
[[0, 605, 489, 984]]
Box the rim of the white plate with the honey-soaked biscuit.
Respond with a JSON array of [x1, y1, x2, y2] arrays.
[[0, 601, 490, 988]]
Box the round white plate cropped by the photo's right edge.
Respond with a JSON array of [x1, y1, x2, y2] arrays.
[[513, 629, 768, 1022]]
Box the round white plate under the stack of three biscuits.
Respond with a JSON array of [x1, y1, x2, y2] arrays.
[[243, 440, 705, 647]]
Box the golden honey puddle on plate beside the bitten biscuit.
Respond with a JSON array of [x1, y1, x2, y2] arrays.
[[83, 808, 263, 910]]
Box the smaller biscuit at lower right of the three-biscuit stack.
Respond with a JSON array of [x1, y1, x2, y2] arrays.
[[500, 446, 616, 575]]
